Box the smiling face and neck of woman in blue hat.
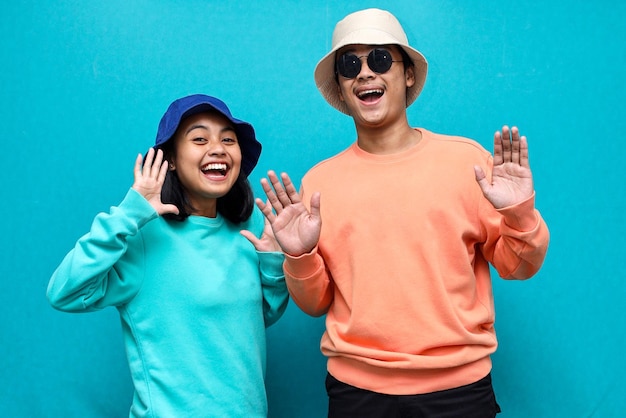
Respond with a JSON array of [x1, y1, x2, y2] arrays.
[[170, 112, 242, 217]]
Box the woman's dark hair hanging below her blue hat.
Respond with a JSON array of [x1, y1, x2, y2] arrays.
[[154, 138, 254, 224]]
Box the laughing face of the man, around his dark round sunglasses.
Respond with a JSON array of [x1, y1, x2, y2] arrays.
[[337, 45, 415, 128]]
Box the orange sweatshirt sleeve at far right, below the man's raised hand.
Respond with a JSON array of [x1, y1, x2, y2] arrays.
[[483, 194, 550, 280]]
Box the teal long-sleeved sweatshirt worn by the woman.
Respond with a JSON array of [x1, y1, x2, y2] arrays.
[[47, 189, 288, 418]]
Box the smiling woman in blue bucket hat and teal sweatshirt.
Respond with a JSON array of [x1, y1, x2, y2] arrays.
[[47, 95, 288, 417]]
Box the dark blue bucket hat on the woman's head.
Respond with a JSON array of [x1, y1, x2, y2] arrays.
[[154, 94, 262, 177]]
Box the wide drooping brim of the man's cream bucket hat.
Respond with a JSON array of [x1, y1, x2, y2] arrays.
[[314, 28, 428, 115]]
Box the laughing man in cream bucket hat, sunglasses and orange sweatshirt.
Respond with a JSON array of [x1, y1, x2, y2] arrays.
[[257, 9, 549, 418]]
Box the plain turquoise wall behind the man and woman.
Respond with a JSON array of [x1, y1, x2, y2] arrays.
[[0, 0, 626, 418]]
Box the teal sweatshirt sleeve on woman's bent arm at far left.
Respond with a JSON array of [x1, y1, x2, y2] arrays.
[[47, 189, 158, 312]]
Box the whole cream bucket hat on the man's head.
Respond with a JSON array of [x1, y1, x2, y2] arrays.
[[315, 9, 428, 115]]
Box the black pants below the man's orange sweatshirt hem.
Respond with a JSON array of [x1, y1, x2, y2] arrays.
[[326, 374, 500, 418]]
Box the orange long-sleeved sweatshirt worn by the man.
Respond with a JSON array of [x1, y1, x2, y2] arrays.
[[285, 129, 549, 394]]
